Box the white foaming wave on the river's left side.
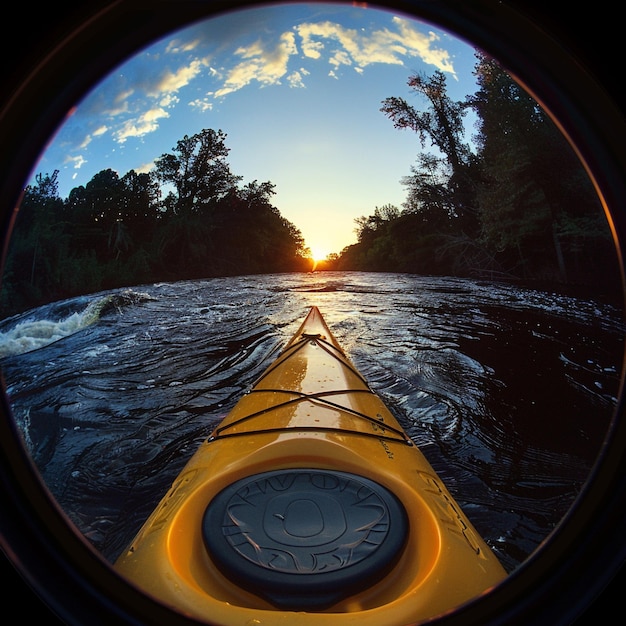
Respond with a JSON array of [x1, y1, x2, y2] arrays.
[[0, 289, 154, 359]]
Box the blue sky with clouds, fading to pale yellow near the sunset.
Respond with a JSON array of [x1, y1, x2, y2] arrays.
[[28, 3, 476, 258]]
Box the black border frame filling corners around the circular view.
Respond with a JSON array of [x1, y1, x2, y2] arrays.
[[0, 0, 626, 626]]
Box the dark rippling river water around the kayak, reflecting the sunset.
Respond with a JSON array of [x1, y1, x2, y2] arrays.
[[0, 272, 624, 571]]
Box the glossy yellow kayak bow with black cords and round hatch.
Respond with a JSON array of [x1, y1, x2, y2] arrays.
[[115, 307, 506, 626]]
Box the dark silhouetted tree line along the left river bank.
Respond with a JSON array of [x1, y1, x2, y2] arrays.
[[0, 129, 311, 315]]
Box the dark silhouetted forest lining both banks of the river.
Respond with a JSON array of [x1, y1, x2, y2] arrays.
[[0, 53, 619, 318]]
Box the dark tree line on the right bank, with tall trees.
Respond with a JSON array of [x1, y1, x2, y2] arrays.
[[326, 53, 619, 287]]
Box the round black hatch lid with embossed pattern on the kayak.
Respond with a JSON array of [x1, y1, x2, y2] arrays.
[[202, 468, 408, 610]]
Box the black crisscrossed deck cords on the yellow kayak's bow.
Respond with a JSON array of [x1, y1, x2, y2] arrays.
[[208, 333, 414, 446]]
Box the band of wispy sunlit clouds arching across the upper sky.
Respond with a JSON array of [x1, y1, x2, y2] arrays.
[[56, 12, 456, 158]]
